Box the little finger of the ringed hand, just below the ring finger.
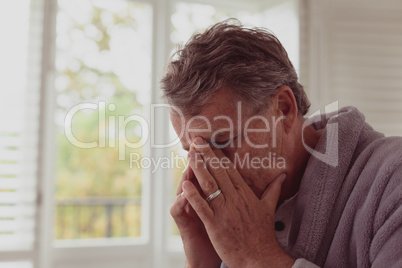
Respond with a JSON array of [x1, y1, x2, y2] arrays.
[[183, 180, 214, 224]]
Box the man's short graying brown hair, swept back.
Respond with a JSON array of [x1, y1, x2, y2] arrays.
[[161, 19, 310, 115]]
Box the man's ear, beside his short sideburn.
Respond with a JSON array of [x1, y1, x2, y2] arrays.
[[273, 86, 299, 133]]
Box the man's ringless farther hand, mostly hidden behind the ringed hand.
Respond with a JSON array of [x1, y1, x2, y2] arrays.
[[170, 167, 222, 268]]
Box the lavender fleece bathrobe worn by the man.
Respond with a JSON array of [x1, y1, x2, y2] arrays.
[[222, 107, 402, 268]]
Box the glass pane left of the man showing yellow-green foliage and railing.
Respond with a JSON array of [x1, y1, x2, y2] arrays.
[[54, 0, 152, 239]]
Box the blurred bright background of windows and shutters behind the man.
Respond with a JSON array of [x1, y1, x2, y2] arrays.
[[0, 0, 402, 268]]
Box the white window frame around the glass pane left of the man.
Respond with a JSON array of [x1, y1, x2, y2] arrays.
[[40, 0, 177, 268]]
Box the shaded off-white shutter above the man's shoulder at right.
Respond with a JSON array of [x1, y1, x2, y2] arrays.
[[309, 0, 402, 135]]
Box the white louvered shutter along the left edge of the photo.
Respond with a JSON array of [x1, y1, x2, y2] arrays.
[[0, 0, 43, 267]]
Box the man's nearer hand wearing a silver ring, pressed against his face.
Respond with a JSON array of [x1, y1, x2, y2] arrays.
[[183, 138, 294, 268]]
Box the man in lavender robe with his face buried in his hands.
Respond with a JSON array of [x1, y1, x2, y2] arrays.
[[162, 21, 402, 268]]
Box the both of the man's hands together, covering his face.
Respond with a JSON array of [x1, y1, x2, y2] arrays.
[[171, 137, 293, 268]]
